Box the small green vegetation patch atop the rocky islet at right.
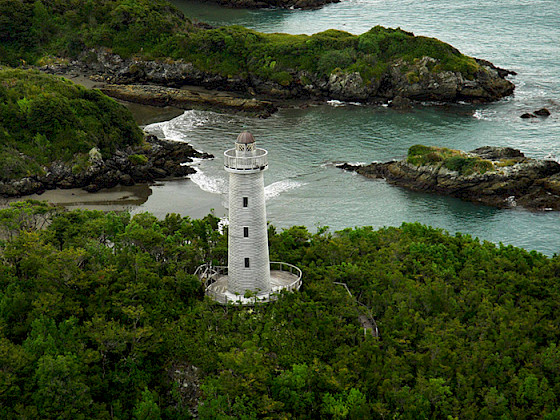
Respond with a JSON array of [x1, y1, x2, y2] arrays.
[[407, 144, 494, 176]]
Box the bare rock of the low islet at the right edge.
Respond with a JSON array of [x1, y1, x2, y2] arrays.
[[339, 146, 560, 210]]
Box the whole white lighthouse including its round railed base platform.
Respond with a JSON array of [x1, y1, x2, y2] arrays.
[[197, 131, 301, 304]]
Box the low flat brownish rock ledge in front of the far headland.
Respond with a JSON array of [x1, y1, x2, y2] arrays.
[[101, 85, 277, 117]]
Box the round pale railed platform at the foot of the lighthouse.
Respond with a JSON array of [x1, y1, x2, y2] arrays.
[[195, 262, 301, 305]]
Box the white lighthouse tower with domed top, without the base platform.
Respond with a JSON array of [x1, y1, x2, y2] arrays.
[[224, 131, 270, 294]]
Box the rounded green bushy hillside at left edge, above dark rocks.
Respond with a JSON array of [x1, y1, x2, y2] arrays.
[[0, 67, 142, 180]]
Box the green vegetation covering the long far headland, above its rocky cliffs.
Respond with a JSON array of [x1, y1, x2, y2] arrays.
[[0, 0, 479, 85]]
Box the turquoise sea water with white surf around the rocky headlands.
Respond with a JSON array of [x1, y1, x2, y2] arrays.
[[137, 0, 560, 255]]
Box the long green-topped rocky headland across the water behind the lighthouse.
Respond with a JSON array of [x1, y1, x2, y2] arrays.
[[0, 0, 514, 110]]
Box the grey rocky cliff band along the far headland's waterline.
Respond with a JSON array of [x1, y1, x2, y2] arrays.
[[42, 50, 514, 103]]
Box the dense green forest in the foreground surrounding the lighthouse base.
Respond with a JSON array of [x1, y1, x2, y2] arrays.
[[0, 202, 560, 419]]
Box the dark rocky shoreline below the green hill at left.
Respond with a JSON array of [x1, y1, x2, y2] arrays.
[[0, 135, 212, 197]]
